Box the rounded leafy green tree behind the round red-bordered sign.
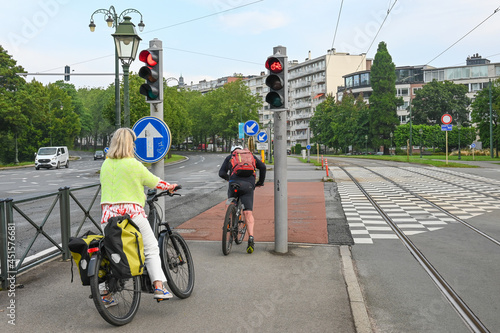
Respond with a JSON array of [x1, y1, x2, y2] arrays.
[[412, 80, 471, 125]]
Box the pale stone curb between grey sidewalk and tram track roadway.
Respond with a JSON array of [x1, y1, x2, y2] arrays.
[[340, 245, 373, 333]]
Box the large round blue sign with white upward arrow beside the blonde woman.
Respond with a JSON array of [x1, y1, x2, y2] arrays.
[[132, 117, 171, 163]]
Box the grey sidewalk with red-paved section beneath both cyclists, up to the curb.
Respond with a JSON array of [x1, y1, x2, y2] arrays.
[[0, 158, 371, 333]]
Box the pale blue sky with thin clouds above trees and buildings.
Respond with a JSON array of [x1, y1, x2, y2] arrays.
[[0, 0, 500, 88]]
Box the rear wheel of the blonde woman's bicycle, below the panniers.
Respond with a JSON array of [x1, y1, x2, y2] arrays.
[[90, 254, 141, 326]]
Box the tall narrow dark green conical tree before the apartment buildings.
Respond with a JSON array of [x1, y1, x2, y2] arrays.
[[369, 42, 403, 154]]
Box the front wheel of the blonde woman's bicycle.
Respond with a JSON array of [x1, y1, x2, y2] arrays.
[[160, 232, 194, 298]]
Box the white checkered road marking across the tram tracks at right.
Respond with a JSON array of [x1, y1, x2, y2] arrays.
[[331, 167, 500, 244]]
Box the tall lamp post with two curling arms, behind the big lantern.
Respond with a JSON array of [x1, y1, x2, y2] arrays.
[[89, 6, 145, 129]]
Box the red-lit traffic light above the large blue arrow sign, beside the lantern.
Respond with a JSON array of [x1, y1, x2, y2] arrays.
[[139, 48, 163, 103]]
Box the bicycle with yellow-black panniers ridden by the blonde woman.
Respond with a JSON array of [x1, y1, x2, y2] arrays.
[[88, 186, 194, 326]]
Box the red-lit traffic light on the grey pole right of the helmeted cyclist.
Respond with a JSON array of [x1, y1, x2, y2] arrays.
[[266, 55, 288, 109]]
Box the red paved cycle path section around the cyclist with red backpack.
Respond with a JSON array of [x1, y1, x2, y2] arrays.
[[176, 182, 328, 244]]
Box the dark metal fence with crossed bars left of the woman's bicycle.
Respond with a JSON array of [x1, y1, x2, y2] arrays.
[[0, 184, 102, 290]]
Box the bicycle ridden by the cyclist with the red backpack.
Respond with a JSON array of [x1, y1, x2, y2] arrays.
[[222, 183, 247, 256]]
